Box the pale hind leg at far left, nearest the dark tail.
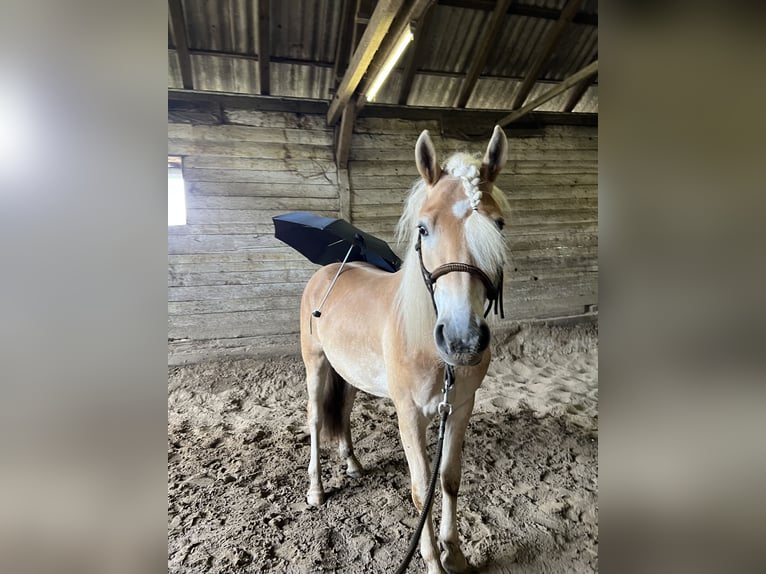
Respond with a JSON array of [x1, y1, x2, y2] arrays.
[[303, 352, 330, 506]]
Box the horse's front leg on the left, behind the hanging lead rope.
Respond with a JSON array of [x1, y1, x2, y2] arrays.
[[396, 402, 443, 574]]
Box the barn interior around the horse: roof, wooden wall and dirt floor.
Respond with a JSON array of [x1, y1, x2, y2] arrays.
[[168, 0, 598, 573]]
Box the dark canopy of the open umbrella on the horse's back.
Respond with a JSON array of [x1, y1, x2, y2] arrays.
[[272, 211, 402, 273]]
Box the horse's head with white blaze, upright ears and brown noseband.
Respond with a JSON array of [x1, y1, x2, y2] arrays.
[[410, 126, 508, 365]]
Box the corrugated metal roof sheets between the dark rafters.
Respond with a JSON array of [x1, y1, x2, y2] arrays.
[[168, 0, 598, 117]]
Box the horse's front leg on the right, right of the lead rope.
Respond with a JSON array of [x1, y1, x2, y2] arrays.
[[439, 395, 474, 573]]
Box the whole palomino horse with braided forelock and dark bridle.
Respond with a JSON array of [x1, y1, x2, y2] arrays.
[[301, 127, 508, 574]]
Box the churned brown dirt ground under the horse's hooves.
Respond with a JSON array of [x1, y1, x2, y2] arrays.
[[168, 322, 598, 573]]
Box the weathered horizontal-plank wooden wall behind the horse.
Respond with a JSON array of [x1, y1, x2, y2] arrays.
[[168, 108, 598, 364]]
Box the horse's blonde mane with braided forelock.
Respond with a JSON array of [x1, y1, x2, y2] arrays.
[[395, 153, 510, 346]]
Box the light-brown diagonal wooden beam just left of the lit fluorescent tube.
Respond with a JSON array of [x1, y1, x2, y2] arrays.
[[327, 0, 404, 125]]
